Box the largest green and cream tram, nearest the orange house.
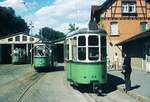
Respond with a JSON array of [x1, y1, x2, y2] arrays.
[[64, 28, 107, 90]]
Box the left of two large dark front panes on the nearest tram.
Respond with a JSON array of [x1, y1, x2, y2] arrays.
[[78, 36, 86, 60]]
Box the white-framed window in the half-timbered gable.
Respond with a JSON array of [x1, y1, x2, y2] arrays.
[[122, 2, 136, 14]]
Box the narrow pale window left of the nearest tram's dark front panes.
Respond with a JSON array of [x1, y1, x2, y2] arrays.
[[72, 37, 77, 60]]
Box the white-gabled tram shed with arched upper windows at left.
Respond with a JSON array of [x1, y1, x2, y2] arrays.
[[0, 32, 40, 64]]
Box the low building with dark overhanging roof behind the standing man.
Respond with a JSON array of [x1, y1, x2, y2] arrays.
[[116, 29, 150, 72]]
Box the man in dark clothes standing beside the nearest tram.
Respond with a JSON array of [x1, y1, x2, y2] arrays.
[[122, 54, 132, 92]]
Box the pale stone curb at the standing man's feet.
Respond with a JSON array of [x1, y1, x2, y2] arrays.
[[117, 85, 150, 102]]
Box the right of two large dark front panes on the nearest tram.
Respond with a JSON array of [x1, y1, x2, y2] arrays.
[[88, 36, 99, 60]]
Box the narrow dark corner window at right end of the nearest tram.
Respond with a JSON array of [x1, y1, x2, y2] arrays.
[[101, 36, 106, 60]]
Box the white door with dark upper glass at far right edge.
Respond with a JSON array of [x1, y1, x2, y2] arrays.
[[145, 44, 150, 72]]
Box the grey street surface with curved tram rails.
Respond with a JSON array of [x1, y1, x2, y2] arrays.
[[0, 65, 138, 102]]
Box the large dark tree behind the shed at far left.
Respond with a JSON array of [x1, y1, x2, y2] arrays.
[[0, 7, 29, 37]]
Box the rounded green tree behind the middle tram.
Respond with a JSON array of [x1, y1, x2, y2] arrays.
[[39, 27, 65, 41]]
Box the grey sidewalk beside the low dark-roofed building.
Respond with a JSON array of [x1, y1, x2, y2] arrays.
[[108, 69, 150, 102]]
